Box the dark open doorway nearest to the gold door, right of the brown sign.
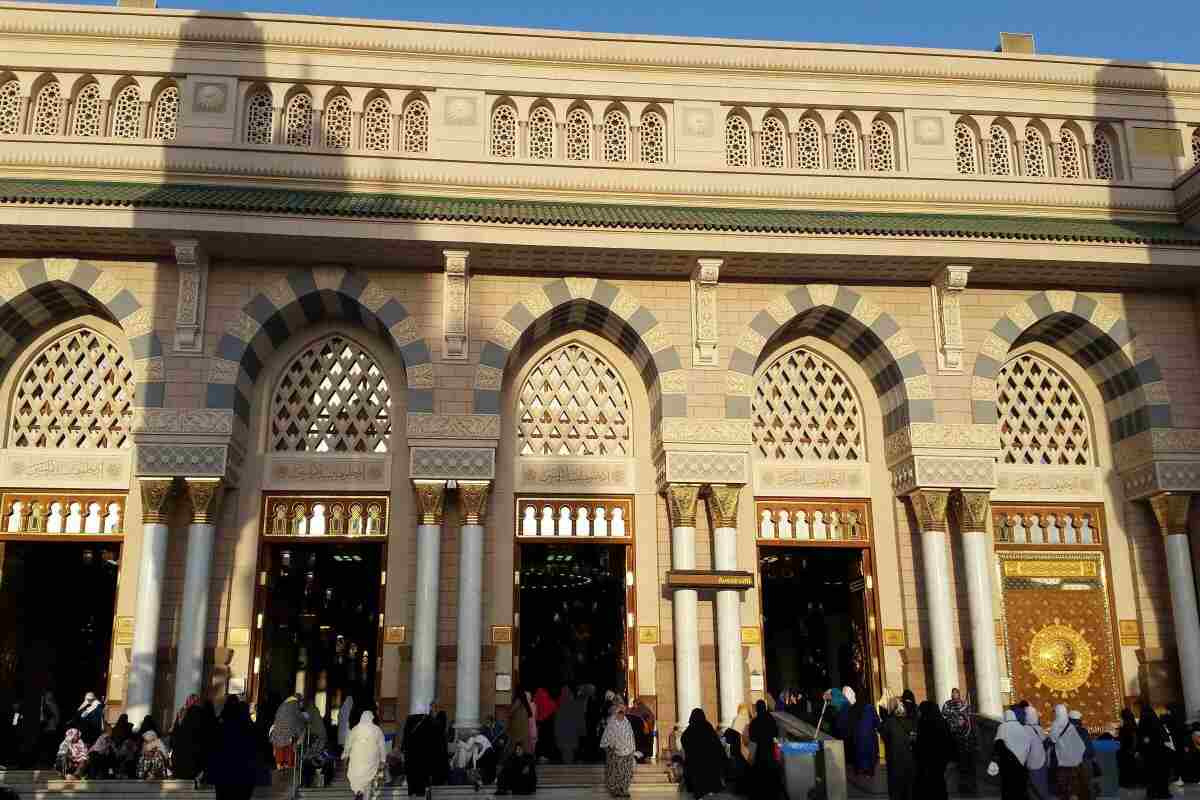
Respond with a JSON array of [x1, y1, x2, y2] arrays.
[[758, 547, 870, 715]]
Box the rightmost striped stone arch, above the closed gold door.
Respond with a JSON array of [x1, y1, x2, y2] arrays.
[[971, 291, 1171, 444]]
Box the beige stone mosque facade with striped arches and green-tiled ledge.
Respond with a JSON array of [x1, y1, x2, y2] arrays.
[[0, 4, 1200, 726]]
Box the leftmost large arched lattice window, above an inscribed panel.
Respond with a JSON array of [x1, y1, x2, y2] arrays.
[[8, 327, 134, 450]]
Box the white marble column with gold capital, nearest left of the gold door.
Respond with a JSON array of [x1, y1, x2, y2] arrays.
[[961, 492, 1003, 720]]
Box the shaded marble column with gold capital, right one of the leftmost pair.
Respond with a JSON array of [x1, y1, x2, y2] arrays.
[[173, 477, 221, 709]]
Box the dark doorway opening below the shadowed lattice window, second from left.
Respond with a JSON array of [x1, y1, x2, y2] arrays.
[[258, 542, 383, 723]]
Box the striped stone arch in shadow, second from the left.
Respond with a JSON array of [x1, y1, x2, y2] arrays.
[[206, 267, 433, 425]]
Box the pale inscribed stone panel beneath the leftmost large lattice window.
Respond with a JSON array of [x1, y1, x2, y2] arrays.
[[0, 447, 132, 489]]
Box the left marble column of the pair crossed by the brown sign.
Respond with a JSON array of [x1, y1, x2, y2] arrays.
[[667, 483, 701, 730]]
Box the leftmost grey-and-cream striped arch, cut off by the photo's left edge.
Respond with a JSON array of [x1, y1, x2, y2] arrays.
[[0, 258, 166, 408]]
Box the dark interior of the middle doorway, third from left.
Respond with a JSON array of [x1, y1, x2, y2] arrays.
[[518, 543, 628, 697]]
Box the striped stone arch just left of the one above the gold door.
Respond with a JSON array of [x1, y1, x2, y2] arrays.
[[725, 283, 936, 437]]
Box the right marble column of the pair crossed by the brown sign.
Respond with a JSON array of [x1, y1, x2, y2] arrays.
[[708, 483, 745, 727]]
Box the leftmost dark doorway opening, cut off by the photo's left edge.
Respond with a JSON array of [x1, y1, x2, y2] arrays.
[[0, 541, 121, 723]]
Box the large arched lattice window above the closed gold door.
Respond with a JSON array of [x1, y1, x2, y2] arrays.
[[996, 353, 1094, 467]]
